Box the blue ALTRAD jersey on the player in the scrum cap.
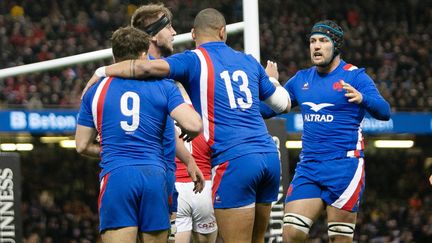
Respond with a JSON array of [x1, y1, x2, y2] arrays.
[[262, 60, 390, 160]]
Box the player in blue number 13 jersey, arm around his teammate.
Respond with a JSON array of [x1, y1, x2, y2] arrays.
[[83, 9, 290, 243]]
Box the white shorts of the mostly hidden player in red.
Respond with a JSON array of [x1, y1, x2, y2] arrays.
[[175, 180, 217, 234]]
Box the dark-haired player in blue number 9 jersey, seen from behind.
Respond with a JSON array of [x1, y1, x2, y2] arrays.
[[75, 27, 202, 243]]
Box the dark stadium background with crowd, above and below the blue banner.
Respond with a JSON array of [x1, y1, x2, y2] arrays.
[[0, 0, 432, 243]]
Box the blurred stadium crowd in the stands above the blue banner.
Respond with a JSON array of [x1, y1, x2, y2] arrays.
[[0, 0, 432, 111]]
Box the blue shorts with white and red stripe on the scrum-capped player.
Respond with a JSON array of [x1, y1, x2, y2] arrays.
[[285, 158, 365, 212]]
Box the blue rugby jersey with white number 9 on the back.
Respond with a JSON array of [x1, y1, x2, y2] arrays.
[[78, 77, 184, 178]]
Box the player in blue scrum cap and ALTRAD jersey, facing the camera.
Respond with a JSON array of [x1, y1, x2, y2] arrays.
[[262, 20, 390, 242]]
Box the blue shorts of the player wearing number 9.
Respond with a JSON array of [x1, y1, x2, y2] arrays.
[[98, 165, 170, 232]]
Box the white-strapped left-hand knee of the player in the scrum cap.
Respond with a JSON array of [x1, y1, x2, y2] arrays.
[[283, 213, 313, 242]]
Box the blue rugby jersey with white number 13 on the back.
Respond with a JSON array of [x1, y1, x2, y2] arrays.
[[166, 42, 277, 166]]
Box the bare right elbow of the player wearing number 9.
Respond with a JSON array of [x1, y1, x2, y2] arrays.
[[170, 103, 203, 142]]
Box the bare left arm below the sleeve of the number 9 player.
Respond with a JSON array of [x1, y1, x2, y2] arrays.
[[75, 125, 100, 158]]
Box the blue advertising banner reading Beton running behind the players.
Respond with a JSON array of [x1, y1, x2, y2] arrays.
[[0, 110, 432, 134]]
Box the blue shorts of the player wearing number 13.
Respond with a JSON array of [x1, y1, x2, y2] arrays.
[[212, 153, 281, 208]]
